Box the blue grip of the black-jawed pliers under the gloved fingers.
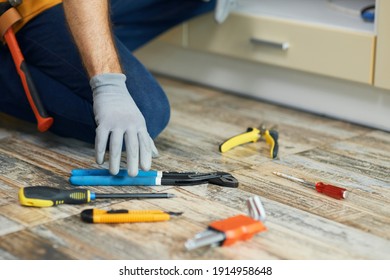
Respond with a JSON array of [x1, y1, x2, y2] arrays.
[[69, 173, 161, 186]]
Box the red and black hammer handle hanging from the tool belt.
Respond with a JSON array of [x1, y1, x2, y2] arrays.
[[4, 27, 53, 132]]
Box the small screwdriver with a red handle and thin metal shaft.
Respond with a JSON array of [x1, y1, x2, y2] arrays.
[[272, 172, 348, 199]]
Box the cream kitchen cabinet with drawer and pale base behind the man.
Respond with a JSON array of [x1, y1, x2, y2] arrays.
[[137, 0, 390, 131]]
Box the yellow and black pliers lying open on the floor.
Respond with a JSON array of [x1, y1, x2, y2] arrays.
[[219, 125, 279, 159]]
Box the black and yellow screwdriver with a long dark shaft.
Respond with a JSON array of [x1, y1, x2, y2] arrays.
[[19, 186, 175, 207]]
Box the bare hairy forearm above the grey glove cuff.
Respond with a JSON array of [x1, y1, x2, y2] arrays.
[[63, 0, 122, 77]]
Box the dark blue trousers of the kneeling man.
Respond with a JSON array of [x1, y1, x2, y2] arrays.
[[0, 0, 215, 143]]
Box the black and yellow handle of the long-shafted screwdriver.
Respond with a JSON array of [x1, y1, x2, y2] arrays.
[[19, 186, 91, 207]]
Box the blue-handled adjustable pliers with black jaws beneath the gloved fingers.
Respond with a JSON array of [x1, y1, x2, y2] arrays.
[[69, 169, 238, 188]]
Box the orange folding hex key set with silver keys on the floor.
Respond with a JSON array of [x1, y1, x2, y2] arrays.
[[184, 196, 267, 250]]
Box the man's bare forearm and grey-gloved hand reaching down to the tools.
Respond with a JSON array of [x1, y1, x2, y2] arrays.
[[63, 0, 157, 176]]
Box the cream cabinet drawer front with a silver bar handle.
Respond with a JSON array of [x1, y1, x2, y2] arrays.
[[188, 13, 375, 84]]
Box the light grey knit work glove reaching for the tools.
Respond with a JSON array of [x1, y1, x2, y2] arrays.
[[90, 73, 158, 176]]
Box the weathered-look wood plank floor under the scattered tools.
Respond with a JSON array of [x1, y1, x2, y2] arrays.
[[0, 77, 390, 260]]
